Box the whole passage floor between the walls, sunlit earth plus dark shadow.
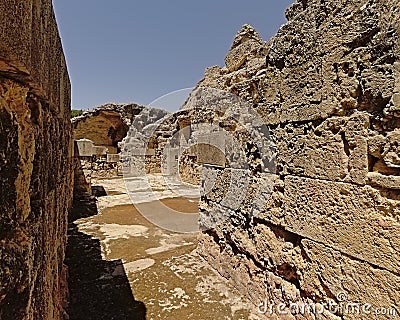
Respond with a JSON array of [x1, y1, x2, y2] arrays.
[[67, 176, 260, 320]]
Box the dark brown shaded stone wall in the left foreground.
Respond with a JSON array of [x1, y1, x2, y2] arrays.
[[0, 0, 73, 320]]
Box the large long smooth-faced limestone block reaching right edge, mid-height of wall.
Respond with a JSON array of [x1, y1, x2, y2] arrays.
[[284, 176, 400, 272]]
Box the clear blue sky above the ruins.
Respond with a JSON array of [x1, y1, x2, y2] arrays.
[[53, 0, 294, 109]]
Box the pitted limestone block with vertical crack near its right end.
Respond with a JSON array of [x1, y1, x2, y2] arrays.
[[271, 112, 369, 184]]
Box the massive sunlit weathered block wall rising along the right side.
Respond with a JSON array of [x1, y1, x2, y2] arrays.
[[199, 0, 400, 319]]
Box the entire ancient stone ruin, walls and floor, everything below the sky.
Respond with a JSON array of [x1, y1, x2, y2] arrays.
[[0, 0, 400, 320]]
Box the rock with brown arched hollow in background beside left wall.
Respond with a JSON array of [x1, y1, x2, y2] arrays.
[[72, 103, 144, 153]]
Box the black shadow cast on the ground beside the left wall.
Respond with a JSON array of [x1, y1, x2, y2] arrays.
[[65, 195, 146, 320]]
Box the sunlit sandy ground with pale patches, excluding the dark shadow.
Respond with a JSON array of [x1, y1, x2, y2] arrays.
[[76, 176, 260, 320]]
